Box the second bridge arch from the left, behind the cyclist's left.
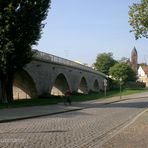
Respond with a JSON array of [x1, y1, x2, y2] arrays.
[[51, 73, 70, 96]]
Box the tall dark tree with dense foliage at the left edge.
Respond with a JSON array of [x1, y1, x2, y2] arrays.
[[0, 0, 50, 102]]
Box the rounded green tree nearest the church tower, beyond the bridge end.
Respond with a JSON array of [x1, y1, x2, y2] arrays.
[[109, 62, 136, 83]]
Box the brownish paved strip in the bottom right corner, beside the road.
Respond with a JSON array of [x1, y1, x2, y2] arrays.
[[102, 111, 148, 148]]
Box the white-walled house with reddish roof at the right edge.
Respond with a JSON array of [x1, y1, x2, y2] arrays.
[[138, 65, 148, 87]]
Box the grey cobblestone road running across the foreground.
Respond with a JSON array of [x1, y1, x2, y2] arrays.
[[0, 98, 148, 148]]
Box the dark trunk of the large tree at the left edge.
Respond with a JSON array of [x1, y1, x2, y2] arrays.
[[0, 72, 13, 103]]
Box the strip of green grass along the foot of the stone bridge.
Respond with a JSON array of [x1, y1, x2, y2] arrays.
[[0, 89, 148, 108]]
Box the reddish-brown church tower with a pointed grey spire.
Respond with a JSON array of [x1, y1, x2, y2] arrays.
[[131, 47, 138, 72]]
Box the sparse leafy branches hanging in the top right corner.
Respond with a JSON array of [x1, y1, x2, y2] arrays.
[[129, 0, 148, 39]]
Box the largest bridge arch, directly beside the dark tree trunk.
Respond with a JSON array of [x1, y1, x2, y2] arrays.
[[13, 70, 37, 99]]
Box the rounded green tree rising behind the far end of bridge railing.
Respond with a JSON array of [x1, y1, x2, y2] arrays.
[[94, 52, 116, 75]]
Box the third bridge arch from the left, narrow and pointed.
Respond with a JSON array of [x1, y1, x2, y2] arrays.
[[78, 77, 88, 94]]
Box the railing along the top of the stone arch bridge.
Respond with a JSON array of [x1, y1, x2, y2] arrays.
[[33, 50, 107, 77]]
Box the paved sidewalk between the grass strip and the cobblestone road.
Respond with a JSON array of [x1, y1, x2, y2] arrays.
[[0, 92, 148, 122]]
